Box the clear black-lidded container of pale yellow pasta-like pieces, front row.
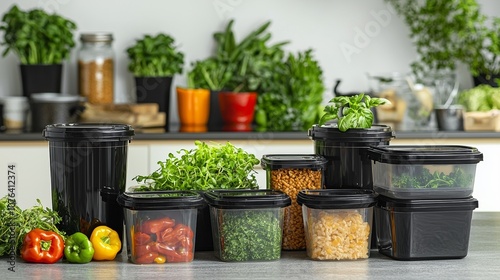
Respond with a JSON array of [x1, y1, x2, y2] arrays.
[[297, 189, 376, 260]]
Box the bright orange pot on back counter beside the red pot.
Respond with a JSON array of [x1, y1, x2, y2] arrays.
[[176, 87, 210, 127]]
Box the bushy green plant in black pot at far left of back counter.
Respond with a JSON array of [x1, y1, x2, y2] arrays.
[[0, 5, 76, 96]]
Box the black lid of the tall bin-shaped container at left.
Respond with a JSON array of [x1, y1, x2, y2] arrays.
[[42, 123, 135, 142]]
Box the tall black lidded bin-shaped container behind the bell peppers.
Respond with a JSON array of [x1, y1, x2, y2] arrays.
[[43, 123, 134, 243]]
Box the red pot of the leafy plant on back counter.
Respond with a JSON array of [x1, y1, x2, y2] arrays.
[[219, 92, 257, 125]]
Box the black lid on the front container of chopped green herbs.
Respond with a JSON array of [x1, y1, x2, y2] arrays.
[[203, 189, 291, 209]]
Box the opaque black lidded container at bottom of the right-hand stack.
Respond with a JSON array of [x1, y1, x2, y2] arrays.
[[375, 195, 478, 260]]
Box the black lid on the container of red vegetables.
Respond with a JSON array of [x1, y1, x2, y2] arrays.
[[116, 191, 205, 210]]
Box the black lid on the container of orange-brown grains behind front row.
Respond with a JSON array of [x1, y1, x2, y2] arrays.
[[260, 154, 328, 170]]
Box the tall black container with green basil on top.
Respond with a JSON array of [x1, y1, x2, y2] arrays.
[[308, 94, 394, 189]]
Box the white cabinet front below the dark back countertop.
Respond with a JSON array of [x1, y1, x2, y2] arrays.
[[0, 139, 500, 211]]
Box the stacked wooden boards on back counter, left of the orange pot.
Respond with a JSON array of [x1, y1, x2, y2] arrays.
[[80, 103, 166, 128]]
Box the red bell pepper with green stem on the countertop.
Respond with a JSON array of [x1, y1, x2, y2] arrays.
[[21, 228, 64, 263]]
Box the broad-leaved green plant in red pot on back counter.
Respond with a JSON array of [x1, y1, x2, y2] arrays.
[[193, 20, 287, 130]]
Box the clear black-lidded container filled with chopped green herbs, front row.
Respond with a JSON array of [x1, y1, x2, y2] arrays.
[[204, 189, 291, 262]]
